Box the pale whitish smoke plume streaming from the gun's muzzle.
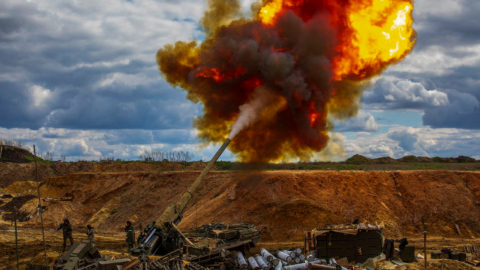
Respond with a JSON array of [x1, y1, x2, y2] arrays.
[[228, 85, 275, 139]]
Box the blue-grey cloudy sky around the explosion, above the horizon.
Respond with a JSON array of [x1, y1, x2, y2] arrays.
[[0, 0, 480, 160]]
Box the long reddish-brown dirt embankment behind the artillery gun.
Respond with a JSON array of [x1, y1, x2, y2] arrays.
[[0, 171, 480, 241]]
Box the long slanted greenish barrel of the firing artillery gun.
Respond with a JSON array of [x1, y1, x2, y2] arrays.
[[156, 139, 230, 224]]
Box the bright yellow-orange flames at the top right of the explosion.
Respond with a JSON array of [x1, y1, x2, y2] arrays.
[[258, 0, 415, 81]]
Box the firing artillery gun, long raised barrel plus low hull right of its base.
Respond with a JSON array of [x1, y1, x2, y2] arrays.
[[130, 139, 260, 256]]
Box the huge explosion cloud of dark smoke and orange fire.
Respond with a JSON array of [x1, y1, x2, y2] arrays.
[[157, 0, 416, 162]]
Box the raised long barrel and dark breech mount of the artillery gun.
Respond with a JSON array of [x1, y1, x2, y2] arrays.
[[131, 139, 230, 255]]
